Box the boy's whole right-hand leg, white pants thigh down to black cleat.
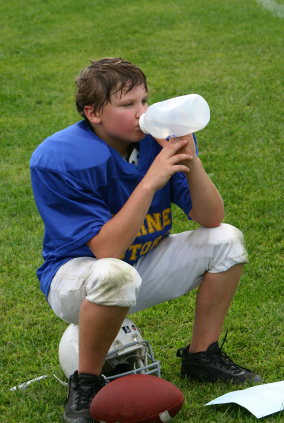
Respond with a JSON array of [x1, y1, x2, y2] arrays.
[[130, 224, 261, 382]]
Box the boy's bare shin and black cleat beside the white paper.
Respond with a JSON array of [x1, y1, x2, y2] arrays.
[[177, 264, 262, 383]]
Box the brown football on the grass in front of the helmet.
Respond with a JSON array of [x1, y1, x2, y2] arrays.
[[90, 374, 184, 423]]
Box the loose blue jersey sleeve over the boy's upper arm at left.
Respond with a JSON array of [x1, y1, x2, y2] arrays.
[[31, 168, 112, 254]]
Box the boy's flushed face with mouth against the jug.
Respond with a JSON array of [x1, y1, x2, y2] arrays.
[[92, 84, 148, 155]]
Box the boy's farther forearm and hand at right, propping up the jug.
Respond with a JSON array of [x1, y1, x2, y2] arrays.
[[156, 134, 224, 228]]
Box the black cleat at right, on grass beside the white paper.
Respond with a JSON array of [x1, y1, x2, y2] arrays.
[[177, 337, 262, 383]]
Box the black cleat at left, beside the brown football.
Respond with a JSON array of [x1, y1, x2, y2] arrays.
[[63, 370, 105, 423]]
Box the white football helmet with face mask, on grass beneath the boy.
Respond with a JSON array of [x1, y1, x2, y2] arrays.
[[59, 317, 161, 381]]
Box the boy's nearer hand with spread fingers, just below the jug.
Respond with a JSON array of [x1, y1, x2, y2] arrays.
[[142, 138, 193, 191]]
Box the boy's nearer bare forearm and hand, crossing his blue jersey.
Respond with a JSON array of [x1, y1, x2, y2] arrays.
[[87, 140, 192, 259]]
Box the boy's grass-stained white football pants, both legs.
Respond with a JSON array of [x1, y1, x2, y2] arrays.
[[48, 223, 248, 324]]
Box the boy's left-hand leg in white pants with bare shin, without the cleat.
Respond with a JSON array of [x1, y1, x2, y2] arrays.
[[48, 257, 141, 375]]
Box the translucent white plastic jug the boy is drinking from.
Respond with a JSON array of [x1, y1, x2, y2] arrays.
[[139, 94, 210, 138]]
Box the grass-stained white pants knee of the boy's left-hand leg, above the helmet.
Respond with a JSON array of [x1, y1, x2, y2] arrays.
[[86, 258, 142, 307]]
